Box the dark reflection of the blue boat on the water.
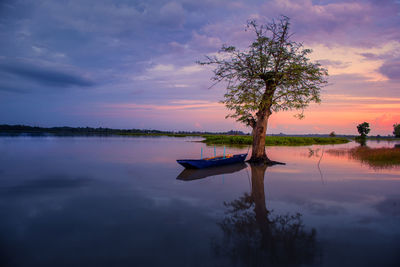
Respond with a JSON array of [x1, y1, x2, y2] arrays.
[[176, 162, 247, 181]]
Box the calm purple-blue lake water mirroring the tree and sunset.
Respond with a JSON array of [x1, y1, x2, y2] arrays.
[[0, 137, 400, 266]]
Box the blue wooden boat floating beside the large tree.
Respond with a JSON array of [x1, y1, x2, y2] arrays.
[[177, 153, 247, 169]]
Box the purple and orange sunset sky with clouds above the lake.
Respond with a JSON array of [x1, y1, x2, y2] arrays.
[[0, 0, 400, 135]]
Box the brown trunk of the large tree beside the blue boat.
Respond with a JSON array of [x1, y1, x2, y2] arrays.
[[249, 111, 271, 163]]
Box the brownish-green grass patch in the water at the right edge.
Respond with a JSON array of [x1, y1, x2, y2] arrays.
[[327, 146, 400, 169]]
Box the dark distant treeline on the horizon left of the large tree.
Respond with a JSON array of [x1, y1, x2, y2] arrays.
[[0, 124, 246, 136]]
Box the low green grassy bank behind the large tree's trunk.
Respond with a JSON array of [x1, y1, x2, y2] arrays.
[[203, 135, 349, 146]]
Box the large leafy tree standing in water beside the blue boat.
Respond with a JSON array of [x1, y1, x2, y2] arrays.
[[198, 16, 328, 163]]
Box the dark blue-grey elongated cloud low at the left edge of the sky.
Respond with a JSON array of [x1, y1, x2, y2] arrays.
[[0, 62, 94, 87]]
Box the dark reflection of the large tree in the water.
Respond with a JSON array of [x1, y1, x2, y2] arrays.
[[215, 164, 316, 266]]
